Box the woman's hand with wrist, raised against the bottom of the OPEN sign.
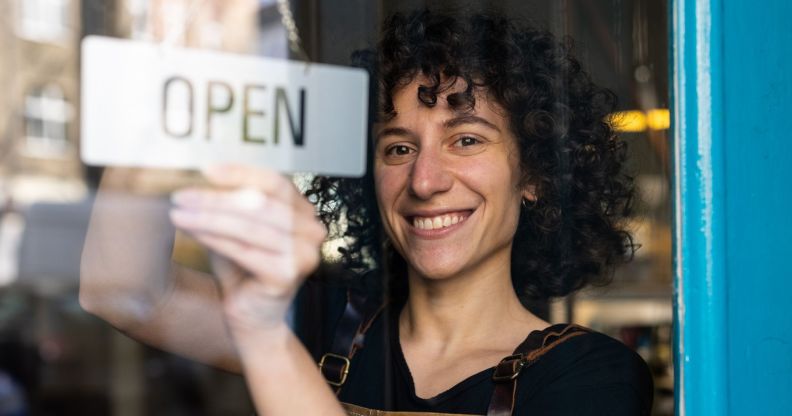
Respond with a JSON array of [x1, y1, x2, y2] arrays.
[[170, 165, 327, 333]]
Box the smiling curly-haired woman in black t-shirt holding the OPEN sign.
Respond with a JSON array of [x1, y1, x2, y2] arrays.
[[81, 8, 651, 414]]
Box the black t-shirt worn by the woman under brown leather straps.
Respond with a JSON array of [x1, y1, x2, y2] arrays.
[[300, 280, 653, 415]]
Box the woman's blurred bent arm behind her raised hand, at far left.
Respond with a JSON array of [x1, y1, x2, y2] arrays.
[[80, 169, 241, 372]]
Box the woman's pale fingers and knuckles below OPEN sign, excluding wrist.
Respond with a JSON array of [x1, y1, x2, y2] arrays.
[[170, 165, 327, 288]]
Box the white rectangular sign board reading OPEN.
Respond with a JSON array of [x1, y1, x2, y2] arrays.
[[81, 36, 368, 176]]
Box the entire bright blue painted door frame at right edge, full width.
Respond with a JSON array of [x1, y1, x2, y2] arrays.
[[671, 0, 792, 415]]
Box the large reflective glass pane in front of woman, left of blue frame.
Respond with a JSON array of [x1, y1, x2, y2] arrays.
[[0, 0, 674, 415]]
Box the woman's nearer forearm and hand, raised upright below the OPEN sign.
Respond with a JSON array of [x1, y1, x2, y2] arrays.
[[171, 166, 345, 415]]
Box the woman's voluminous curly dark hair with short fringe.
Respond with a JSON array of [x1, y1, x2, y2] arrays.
[[307, 11, 634, 299]]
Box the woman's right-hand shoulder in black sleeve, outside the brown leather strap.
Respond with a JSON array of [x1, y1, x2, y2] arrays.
[[516, 325, 653, 415]]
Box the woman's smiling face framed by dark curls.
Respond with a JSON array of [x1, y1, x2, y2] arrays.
[[374, 78, 530, 279]]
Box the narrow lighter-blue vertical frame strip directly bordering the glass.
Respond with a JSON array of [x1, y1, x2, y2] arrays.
[[671, 0, 728, 415]]
